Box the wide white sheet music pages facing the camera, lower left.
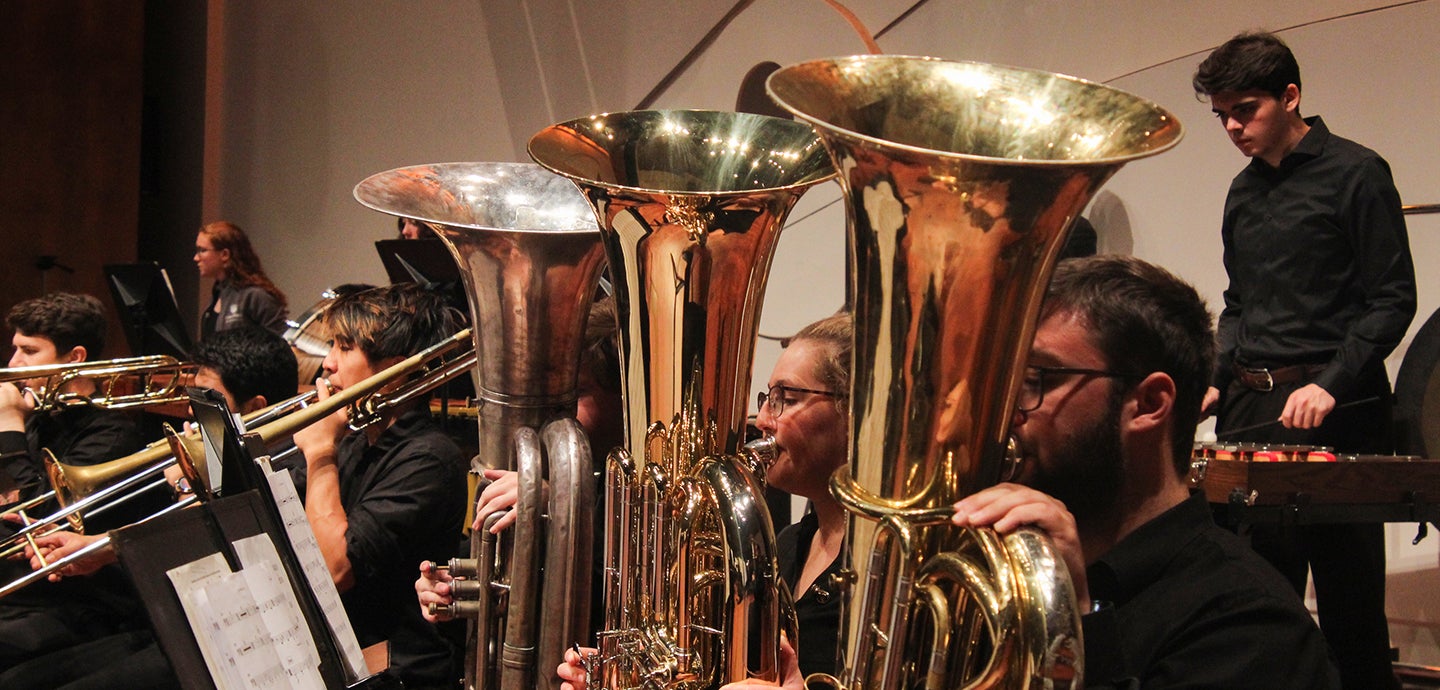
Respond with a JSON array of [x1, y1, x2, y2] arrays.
[[167, 534, 325, 690]]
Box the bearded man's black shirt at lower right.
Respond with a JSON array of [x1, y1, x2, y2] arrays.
[[1081, 494, 1339, 690]]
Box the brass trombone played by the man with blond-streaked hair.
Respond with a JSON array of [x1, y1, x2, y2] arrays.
[[0, 328, 477, 598]]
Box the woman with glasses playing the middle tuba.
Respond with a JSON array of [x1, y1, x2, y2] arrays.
[[544, 314, 852, 690]]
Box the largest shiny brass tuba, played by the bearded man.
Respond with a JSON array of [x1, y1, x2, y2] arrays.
[[768, 55, 1181, 690]]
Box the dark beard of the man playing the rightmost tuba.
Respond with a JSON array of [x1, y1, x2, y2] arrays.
[[1028, 400, 1125, 521]]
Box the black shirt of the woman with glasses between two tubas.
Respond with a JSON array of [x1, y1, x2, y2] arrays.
[[775, 513, 841, 676]]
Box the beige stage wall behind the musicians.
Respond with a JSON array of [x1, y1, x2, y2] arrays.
[[208, 0, 1440, 664]]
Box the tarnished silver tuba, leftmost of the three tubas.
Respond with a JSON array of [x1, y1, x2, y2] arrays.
[[356, 163, 605, 690]]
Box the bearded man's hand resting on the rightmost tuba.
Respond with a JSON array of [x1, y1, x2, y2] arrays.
[[950, 484, 1090, 611]]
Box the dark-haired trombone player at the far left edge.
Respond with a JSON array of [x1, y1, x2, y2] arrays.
[[0, 292, 147, 674]]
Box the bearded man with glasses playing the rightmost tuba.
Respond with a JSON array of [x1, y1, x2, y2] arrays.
[[953, 255, 1339, 689]]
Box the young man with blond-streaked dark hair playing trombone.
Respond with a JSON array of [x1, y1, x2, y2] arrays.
[[295, 284, 467, 689]]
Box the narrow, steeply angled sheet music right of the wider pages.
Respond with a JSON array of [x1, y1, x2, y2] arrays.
[[262, 458, 370, 681]]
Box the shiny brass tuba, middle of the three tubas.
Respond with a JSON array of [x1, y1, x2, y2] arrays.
[[530, 111, 834, 690]]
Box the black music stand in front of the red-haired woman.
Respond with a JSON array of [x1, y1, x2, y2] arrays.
[[105, 262, 192, 360]]
